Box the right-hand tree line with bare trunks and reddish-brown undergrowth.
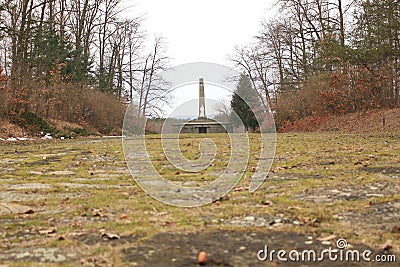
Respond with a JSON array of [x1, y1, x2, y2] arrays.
[[231, 0, 400, 130]]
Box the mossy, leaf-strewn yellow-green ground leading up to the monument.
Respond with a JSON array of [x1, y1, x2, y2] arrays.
[[0, 133, 400, 266]]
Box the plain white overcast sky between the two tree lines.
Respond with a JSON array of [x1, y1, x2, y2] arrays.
[[123, 0, 275, 115]]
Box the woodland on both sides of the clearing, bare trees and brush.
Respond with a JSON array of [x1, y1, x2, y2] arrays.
[[0, 0, 400, 137]]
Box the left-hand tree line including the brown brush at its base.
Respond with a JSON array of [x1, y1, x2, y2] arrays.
[[0, 0, 168, 134]]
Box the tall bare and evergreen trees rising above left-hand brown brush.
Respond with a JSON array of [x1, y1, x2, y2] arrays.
[[0, 0, 168, 119]]
